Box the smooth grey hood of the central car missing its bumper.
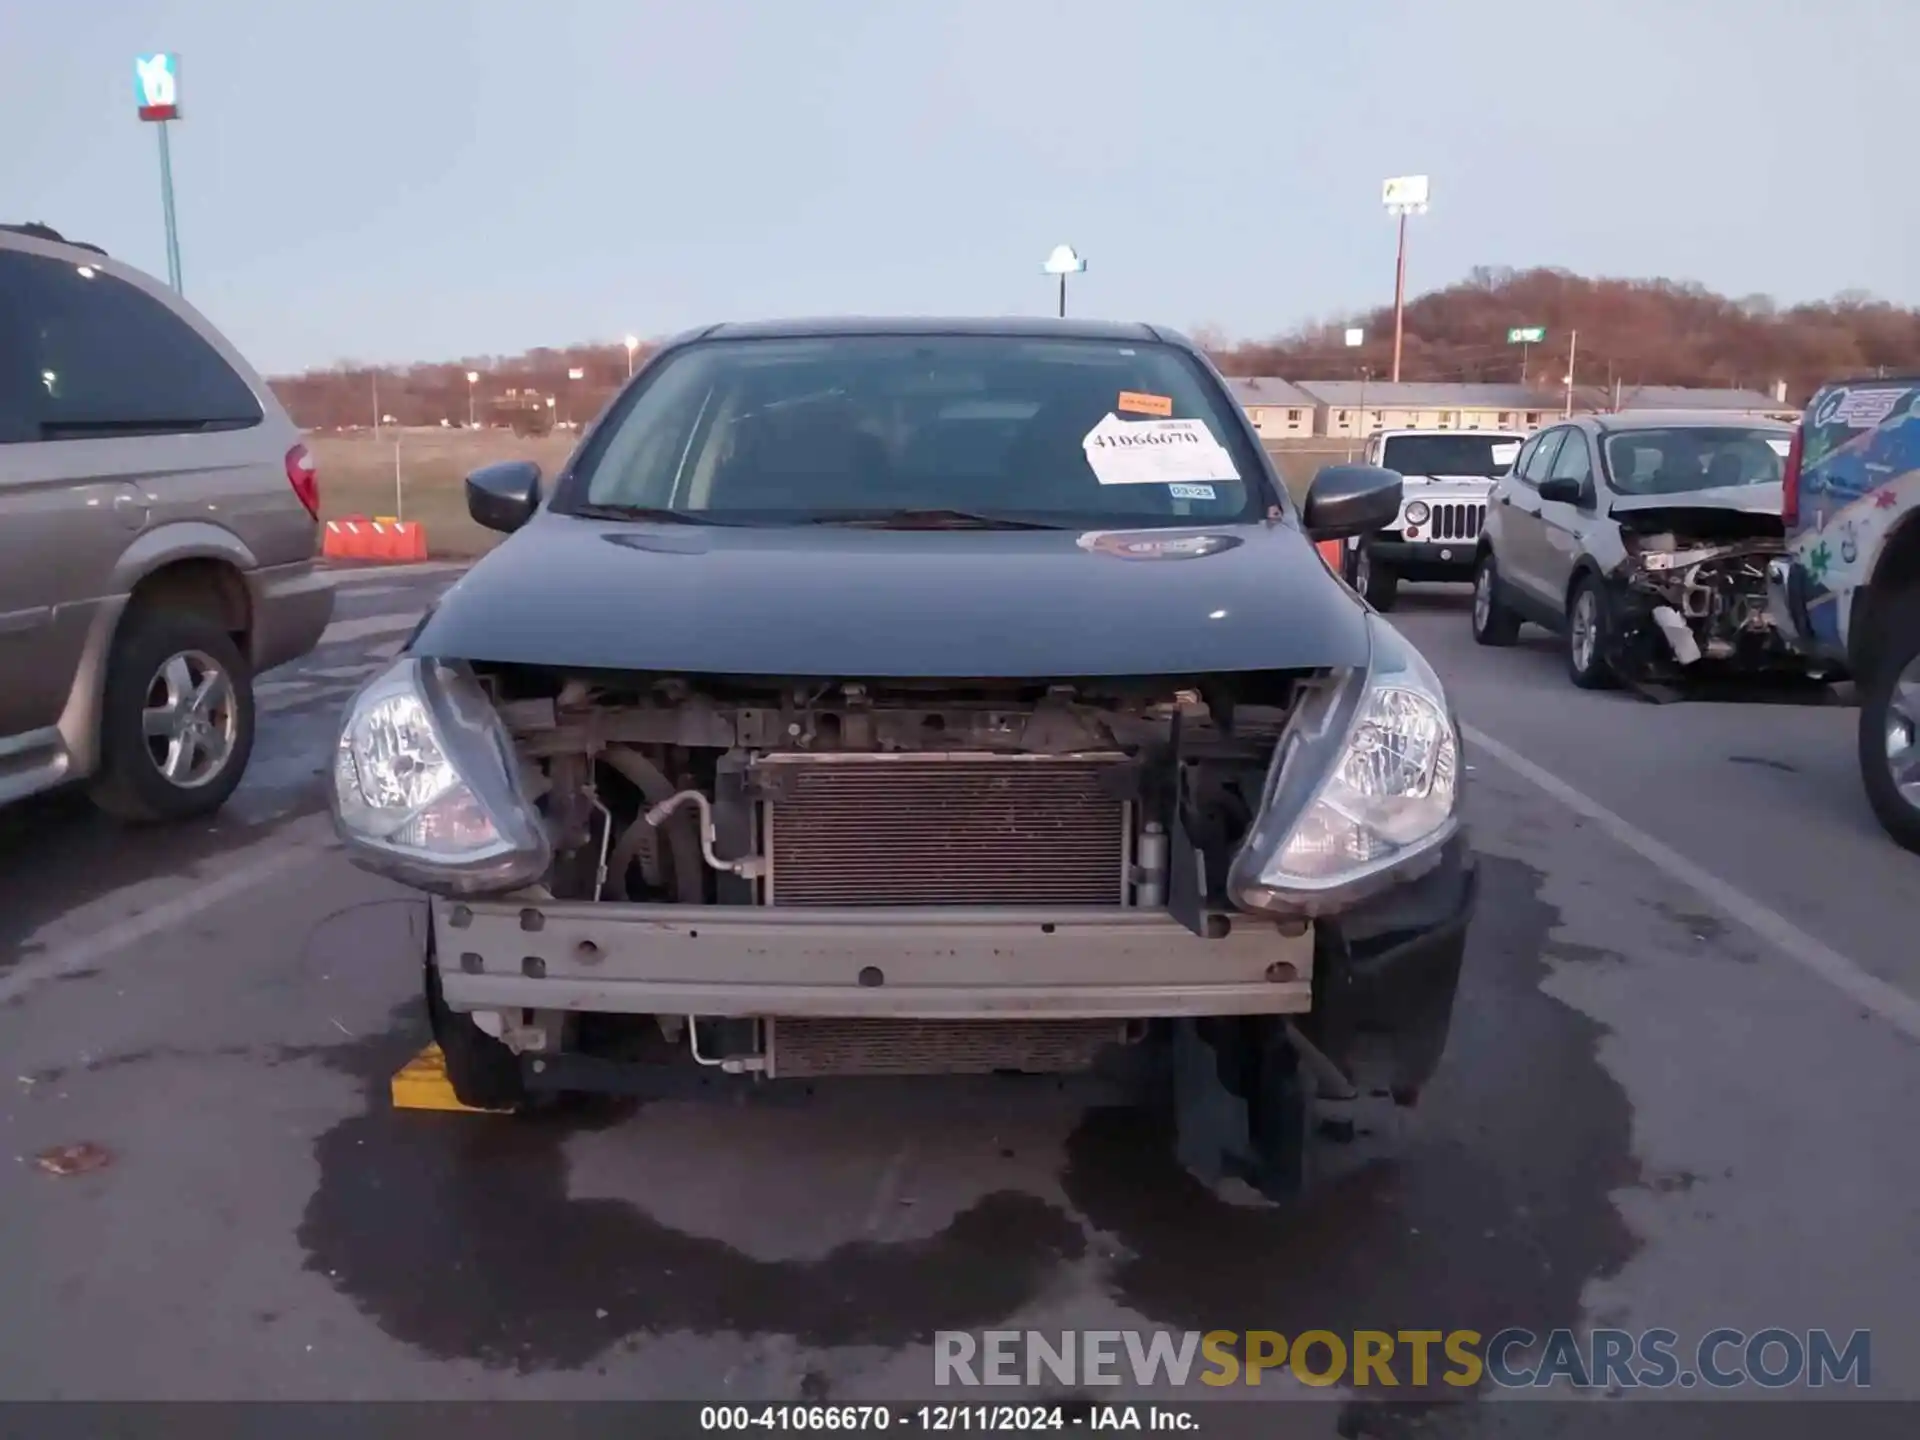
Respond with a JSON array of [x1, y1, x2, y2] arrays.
[[411, 511, 1369, 680]]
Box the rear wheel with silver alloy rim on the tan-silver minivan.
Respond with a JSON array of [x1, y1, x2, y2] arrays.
[[90, 603, 253, 824]]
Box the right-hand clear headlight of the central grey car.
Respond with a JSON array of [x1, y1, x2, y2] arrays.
[[1227, 614, 1459, 914]]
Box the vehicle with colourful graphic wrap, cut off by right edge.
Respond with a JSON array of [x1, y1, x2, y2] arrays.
[[1768, 374, 1920, 851]]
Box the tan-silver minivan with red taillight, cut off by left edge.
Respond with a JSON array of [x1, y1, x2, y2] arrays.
[[0, 225, 332, 820]]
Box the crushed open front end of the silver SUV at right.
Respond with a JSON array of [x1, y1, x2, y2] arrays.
[[1615, 507, 1803, 674]]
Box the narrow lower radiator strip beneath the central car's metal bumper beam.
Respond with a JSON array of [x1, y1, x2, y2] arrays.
[[766, 1020, 1125, 1077]]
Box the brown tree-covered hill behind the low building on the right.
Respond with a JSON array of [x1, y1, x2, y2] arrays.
[[1202, 269, 1920, 401]]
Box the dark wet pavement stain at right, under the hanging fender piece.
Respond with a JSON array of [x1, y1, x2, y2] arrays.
[[1064, 856, 1640, 1400]]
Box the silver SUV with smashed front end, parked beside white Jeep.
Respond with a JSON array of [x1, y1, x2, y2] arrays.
[[1473, 411, 1807, 689]]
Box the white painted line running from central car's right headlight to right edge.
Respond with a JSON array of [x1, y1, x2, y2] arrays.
[[1459, 726, 1920, 1041]]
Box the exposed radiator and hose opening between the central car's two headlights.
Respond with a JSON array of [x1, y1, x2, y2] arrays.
[[486, 672, 1313, 925]]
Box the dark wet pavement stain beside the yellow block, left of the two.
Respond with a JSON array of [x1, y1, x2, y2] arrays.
[[298, 1006, 1085, 1371]]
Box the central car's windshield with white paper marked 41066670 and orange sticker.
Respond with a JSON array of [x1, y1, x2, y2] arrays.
[[555, 336, 1273, 526]]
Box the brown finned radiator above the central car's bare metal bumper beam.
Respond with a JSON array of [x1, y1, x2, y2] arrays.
[[760, 755, 1131, 906]]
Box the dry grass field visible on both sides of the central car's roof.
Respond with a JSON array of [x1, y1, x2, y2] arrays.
[[307, 430, 1346, 559]]
